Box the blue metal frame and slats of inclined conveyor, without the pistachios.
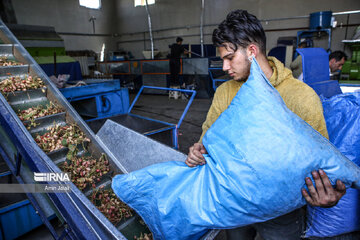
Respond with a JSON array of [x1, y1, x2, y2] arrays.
[[0, 18, 216, 239]]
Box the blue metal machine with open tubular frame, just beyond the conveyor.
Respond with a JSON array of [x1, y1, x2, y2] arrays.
[[59, 79, 196, 149]]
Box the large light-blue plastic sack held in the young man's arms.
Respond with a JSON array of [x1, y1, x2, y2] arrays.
[[112, 60, 360, 239]]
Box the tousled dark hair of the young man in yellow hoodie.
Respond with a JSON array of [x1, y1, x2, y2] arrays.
[[212, 10, 266, 55]]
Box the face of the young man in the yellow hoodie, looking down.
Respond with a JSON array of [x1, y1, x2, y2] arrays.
[[219, 46, 251, 81]]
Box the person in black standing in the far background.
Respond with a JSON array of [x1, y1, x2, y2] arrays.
[[170, 37, 188, 88]]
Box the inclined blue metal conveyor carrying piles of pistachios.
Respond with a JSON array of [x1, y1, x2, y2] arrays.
[[0, 21, 214, 239]]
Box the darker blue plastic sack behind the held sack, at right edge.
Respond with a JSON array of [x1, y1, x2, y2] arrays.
[[306, 92, 360, 237]]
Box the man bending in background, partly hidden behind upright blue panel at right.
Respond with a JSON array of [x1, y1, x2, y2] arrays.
[[290, 51, 347, 81]]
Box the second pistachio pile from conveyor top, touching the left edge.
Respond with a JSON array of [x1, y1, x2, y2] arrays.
[[0, 76, 45, 93]]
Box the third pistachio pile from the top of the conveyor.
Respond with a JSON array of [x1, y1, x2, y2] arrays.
[[17, 102, 63, 128]]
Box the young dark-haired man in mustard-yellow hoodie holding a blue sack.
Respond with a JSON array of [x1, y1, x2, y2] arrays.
[[186, 10, 346, 240]]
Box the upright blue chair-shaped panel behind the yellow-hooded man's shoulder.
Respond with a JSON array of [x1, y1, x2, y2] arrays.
[[296, 48, 342, 98]]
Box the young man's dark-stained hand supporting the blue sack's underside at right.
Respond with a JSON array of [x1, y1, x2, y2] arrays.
[[301, 170, 346, 207]]
